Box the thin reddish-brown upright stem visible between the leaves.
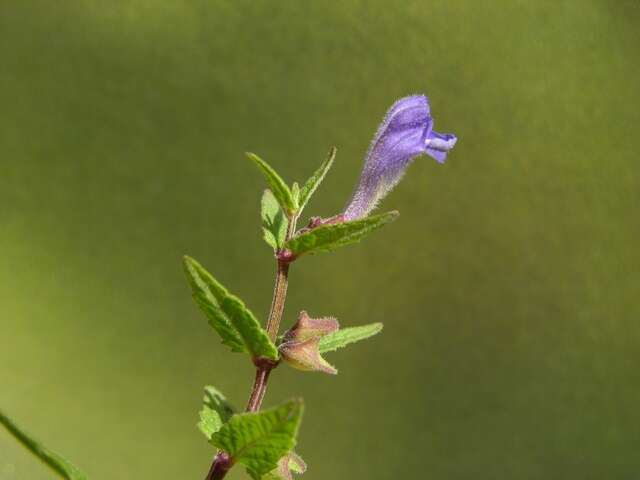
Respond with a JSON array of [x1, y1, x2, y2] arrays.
[[205, 214, 298, 480]]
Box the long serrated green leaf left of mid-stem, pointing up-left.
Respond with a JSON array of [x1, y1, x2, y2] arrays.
[[184, 256, 278, 360]]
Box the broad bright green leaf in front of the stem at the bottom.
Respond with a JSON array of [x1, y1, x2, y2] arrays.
[[211, 399, 303, 479]]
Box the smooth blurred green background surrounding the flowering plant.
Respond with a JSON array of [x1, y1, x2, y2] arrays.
[[0, 0, 640, 480]]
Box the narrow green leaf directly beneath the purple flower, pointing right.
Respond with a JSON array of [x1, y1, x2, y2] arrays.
[[285, 211, 399, 256]]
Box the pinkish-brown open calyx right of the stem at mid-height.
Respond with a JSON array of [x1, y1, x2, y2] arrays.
[[278, 310, 339, 375]]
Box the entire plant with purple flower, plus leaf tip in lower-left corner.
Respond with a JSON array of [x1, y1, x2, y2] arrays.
[[0, 95, 456, 480]]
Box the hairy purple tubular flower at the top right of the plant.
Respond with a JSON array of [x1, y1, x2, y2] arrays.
[[344, 95, 457, 220]]
